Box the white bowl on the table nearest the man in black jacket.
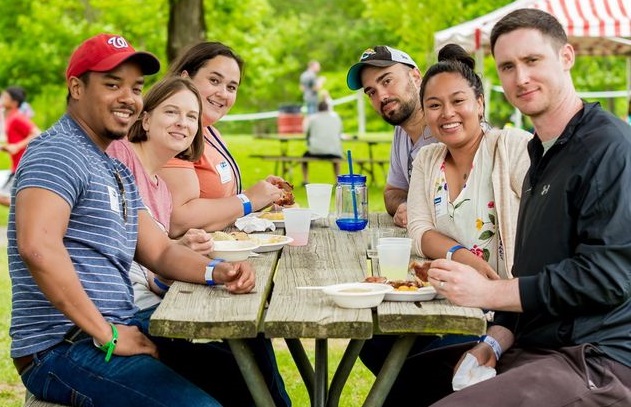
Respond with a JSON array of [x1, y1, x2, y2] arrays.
[[322, 283, 393, 308]]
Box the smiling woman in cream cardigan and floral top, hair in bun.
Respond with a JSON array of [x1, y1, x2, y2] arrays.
[[408, 44, 532, 278]]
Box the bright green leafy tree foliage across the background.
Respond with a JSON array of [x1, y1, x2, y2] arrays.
[[0, 0, 626, 132]]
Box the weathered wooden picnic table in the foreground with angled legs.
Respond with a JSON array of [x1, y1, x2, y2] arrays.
[[150, 213, 486, 407]]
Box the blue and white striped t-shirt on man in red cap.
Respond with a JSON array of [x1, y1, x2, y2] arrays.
[[7, 115, 144, 357]]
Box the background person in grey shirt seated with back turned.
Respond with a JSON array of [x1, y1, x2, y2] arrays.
[[302, 100, 342, 184]]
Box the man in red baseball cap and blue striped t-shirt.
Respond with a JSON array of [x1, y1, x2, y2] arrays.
[[7, 34, 255, 407]]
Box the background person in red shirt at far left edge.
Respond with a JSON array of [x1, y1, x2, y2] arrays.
[[0, 86, 41, 206]]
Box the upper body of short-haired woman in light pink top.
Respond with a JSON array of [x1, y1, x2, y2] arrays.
[[106, 78, 213, 309]]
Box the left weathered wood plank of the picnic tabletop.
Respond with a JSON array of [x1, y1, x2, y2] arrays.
[[150, 251, 279, 339]]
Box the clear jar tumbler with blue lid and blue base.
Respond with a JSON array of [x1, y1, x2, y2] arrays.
[[335, 174, 368, 231]]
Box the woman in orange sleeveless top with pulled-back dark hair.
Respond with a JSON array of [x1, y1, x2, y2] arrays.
[[160, 42, 281, 236]]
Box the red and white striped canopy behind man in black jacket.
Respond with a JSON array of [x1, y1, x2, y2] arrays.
[[434, 0, 631, 56]]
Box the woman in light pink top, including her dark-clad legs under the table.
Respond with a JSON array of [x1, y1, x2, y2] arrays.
[[107, 76, 291, 406]]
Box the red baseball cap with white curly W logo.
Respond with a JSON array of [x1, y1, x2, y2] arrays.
[[66, 34, 160, 80]]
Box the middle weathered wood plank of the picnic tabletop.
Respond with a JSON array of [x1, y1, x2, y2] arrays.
[[265, 216, 373, 339]]
